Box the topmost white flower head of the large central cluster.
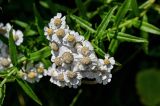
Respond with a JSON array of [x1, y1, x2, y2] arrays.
[[49, 13, 66, 29]]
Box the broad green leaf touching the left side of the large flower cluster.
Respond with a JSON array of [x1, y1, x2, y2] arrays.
[[28, 46, 51, 60]]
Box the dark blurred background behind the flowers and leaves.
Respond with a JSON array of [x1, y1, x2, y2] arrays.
[[0, 0, 160, 106]]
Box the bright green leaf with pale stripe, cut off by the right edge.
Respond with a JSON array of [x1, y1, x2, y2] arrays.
[[133, 20, 160, 35]]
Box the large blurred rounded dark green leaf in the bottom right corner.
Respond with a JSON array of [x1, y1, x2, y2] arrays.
[[136, 69, 160, 106]]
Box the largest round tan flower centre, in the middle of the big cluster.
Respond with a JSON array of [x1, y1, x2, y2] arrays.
[[62, 52, 74, 64]]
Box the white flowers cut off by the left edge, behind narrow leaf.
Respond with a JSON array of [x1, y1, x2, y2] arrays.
[[0, 23, 23, 71]]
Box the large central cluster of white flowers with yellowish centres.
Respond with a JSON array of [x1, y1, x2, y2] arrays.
[[44, 13, 115, 88]]
